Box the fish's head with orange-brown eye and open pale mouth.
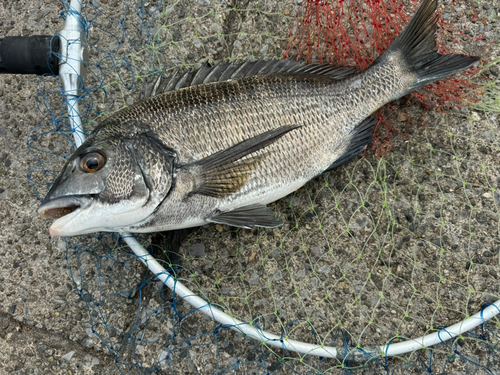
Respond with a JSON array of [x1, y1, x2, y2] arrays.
[[38, 129, 175, 236]]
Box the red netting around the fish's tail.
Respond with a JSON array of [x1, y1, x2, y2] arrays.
[[284, 0, 490, 156]]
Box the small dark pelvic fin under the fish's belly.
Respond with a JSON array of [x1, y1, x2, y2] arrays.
[[206, 204, 283, 229]]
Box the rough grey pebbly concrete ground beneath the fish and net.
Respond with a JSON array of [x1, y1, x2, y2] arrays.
[[0, 0, 500, 374]]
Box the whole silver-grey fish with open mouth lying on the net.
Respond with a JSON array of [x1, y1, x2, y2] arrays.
[[38, 0, 479, 236]]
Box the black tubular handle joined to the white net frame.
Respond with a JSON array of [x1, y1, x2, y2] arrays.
[[0, 35, 60, 75]]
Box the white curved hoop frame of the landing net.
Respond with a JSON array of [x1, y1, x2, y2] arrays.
[[59, 0, 500, 362]]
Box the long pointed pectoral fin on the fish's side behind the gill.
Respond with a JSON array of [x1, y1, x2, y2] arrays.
[[184, 125, 299, 198]]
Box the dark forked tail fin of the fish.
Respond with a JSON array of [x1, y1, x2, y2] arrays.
[[375, 0, 479, 94]]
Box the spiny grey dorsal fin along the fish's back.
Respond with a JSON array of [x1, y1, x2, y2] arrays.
[[141, 60, 357, 100]]
